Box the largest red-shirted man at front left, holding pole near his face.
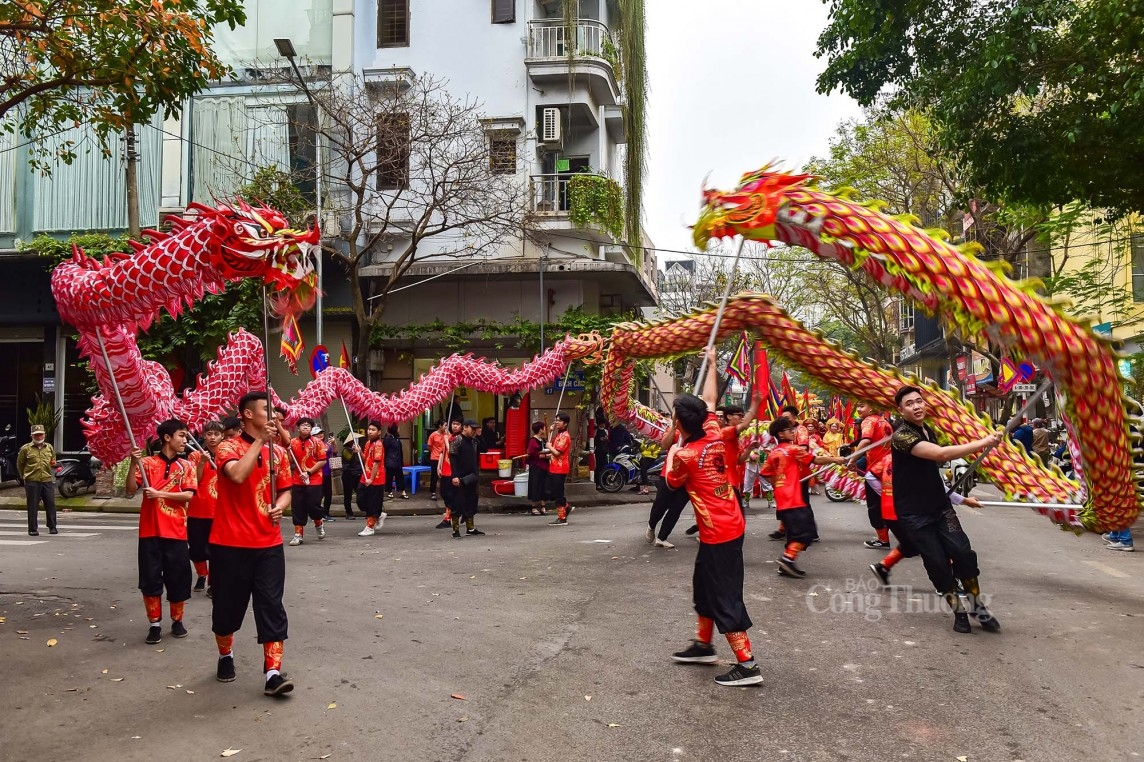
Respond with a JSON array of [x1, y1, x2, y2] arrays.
[[210, 391, 294, 696]]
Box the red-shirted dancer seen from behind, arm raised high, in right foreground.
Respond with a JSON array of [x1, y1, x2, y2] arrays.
[[665, 349, 763, 686]]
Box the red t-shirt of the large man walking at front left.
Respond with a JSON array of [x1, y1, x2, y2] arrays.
[[210, 432, 291, 548]]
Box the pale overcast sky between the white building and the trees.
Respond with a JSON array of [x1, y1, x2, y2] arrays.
[[644, 0, 859, 261]]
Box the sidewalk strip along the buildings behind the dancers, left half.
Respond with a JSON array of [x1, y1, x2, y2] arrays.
[[0, 482, 654, 518]]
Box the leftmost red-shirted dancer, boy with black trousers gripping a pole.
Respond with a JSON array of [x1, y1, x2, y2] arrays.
[[126, 419, 197, 645]]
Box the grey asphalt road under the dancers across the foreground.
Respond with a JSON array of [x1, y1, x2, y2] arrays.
[[0, 489, 1144, 762]]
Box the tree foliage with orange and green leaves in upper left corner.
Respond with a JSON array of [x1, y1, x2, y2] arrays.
[[0, 0, 246, 167]]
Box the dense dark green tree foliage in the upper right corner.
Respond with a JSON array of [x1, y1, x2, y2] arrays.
[[817, 0, 1144, 219]]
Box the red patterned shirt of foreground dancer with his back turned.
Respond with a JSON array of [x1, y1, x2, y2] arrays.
[[666, 427, 746, 545]]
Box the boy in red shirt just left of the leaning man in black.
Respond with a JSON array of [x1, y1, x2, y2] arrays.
[[758, 418, 847, 577]]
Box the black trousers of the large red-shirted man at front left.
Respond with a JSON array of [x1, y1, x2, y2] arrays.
[[210, 545, 287, 643]]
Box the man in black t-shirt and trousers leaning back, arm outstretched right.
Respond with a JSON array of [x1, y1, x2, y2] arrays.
[[890, 387, 1002, 633]]
